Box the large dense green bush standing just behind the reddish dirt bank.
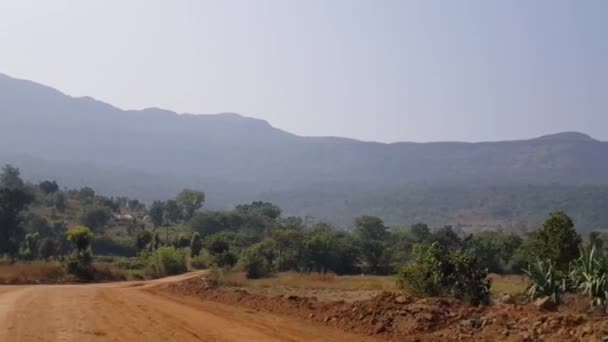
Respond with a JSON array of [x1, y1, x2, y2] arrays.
[[397, 243, 491, 305]]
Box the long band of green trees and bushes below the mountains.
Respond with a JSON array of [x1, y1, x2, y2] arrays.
[[0, 166, 608, 303]]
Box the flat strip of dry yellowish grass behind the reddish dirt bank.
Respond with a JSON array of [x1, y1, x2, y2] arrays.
[[221, 272, 397, 291]]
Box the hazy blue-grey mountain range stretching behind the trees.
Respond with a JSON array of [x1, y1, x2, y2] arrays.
[[0, 74, 608, 228]]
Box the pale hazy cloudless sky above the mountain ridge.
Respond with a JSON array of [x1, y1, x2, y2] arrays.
[[0, 0, 608, 141]]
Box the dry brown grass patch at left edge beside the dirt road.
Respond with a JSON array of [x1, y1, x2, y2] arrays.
[[0, 261, 66, 284]]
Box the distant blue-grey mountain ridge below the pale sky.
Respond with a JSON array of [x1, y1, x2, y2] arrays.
[[0, 74, 608, 231]]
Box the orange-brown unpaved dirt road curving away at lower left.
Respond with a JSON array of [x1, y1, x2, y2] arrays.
[[0, 274, 369, 342]]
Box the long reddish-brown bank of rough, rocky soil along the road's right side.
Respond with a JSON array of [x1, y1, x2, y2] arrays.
[[167, 277, 608, 341]]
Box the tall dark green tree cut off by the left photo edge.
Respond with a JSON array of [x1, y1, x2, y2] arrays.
[[0, 187, 32, 258]]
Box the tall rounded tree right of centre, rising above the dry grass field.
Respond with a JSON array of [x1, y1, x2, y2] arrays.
[[354, 216, 389, 274]]
